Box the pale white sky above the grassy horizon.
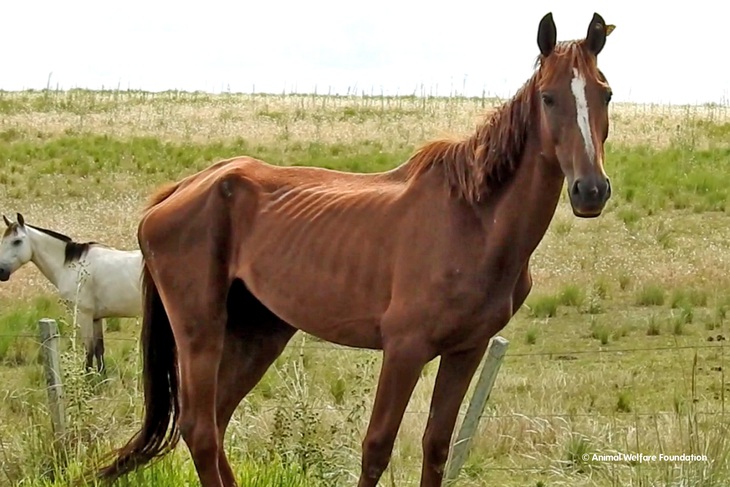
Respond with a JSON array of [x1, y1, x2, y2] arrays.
[[0, 0, 730, 104]]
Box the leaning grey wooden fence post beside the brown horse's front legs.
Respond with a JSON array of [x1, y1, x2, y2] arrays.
[[445, 336, 509, 484]]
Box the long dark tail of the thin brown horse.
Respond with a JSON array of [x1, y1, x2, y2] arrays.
[[98, 263, 180, 480]]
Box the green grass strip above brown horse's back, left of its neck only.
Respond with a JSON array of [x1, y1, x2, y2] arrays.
[[0, 134, 409, 199]]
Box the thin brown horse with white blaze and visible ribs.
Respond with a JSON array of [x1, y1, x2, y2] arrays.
[[100, 14, 611, 487]]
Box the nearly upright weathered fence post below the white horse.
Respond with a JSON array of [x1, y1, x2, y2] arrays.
[[38, 318, 66, 440]]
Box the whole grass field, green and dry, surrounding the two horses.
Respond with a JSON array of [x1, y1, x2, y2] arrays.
[[0, 91, 730, 487]]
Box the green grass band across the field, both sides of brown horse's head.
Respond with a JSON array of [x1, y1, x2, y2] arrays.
[[0, 132, 730, 212]]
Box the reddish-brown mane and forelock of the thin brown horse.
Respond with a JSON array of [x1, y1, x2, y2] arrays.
[[404, 41, 605, 204]]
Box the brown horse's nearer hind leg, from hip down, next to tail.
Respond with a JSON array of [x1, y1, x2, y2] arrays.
[[146, 174, 260, 487]]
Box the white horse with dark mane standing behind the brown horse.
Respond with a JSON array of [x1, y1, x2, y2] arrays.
[[0, 213, 142, 372]]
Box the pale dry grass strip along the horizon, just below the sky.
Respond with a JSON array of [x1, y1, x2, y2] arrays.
[[0, 91, 730, 148]]
